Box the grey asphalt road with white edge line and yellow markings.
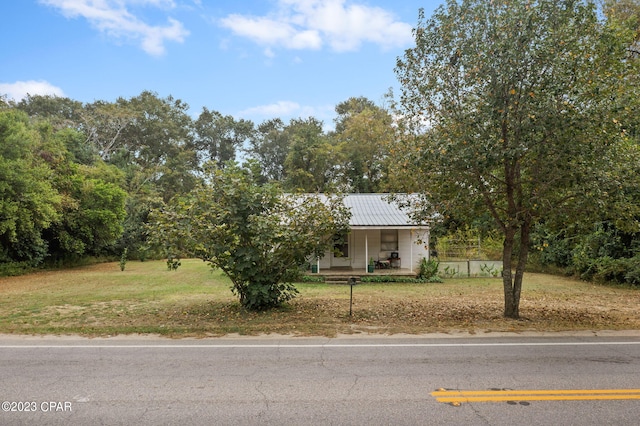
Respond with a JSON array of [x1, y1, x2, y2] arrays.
[[0, 333, 640, 426]]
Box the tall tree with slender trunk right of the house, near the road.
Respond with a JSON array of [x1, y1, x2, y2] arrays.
[[396, 0, 639, 318]]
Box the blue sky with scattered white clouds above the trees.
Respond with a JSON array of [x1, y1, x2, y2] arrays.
[[0, 0, 443, 125]]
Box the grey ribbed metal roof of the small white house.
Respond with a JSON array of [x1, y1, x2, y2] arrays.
[[344, 194, 420, 228]]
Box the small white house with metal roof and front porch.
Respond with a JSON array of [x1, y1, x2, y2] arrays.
[[317, 194, 429, 272]]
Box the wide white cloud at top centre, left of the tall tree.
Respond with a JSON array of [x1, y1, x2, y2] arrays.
[[220, 0, 412, 52]]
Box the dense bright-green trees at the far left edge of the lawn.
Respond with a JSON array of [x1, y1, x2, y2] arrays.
[[0, 108, 126, 266]]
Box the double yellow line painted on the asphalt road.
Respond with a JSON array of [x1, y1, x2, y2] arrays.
[[431, 389, 640, 403]]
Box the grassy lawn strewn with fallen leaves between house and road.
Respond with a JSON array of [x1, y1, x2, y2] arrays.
[[0, 260, 640, 337]]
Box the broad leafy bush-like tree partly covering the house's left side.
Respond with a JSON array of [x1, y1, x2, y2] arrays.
[[152, 164, 348, 310]]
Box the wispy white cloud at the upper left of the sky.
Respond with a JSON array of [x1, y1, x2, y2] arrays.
[[40, 0, 189, 56]]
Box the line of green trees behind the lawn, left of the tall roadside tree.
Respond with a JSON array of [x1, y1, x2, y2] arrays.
[[0, 91, 394, 273]]
